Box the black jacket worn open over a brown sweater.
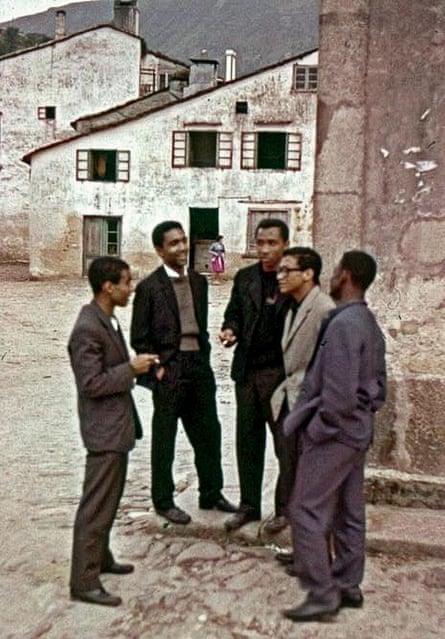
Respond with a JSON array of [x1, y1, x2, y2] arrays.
[[131, 266, 210, 388]]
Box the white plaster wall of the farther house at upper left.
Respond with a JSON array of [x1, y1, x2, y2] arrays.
[[0, 27, 141, 260]]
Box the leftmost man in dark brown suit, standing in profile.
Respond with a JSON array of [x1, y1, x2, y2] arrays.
[[68, 257, 157, 606]]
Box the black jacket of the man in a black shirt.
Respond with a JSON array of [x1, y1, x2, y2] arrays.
[[222, 262, 289, 382]]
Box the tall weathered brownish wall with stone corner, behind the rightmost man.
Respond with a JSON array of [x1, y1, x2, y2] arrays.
[[314, 0, 445, 475]]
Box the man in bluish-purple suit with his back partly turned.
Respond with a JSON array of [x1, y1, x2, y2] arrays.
[[283, 251, 386, 622]]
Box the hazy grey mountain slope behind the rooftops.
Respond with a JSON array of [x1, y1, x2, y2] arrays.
[[0, 0, 318, 75]]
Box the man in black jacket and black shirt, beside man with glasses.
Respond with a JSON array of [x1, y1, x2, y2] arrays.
[[220, 218, 289, 532]]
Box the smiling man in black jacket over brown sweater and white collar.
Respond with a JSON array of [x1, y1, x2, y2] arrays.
[[131, 221, 236, 524]]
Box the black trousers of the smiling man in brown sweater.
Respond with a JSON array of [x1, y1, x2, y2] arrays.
[[151, 352, 223, 509]]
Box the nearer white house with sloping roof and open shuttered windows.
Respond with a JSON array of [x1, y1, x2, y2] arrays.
[[24, 51, 318, 277]]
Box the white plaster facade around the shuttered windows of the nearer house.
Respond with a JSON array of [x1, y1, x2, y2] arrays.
[[30, 56, 316, 276]]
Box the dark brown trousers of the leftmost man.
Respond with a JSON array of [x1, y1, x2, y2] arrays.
[[70, 452, 128, 590]]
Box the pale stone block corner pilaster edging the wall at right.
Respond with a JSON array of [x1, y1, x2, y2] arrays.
[[314, 0, 369, 274]]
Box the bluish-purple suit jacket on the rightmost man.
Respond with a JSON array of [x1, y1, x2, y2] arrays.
[[284, 301, 386, 450]]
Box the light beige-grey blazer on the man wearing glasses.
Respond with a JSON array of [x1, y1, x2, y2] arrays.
[[271, 286, 335, 420]]
